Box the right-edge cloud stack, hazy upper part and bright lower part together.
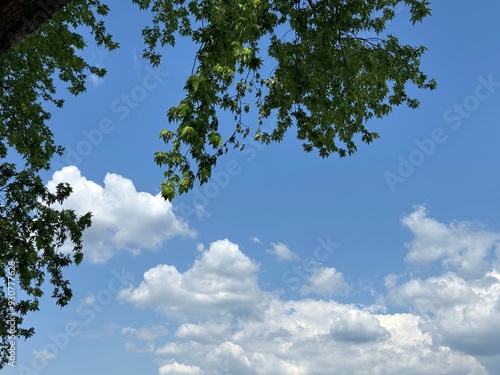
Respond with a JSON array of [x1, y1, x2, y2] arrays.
[[385, 207, 500, 373]]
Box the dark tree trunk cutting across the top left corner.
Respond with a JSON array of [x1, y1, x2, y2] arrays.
[[0, 0, 71, 55]]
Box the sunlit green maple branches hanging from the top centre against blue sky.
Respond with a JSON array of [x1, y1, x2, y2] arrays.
[[138, 0, 436, 200]]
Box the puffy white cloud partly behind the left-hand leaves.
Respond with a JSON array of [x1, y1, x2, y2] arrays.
[[47, 166, 195, 263]]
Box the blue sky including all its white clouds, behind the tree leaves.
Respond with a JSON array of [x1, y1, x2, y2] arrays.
[[5, 1, 500, 375]]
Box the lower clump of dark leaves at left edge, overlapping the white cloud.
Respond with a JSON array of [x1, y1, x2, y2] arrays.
[[0, 162, 91, 363]]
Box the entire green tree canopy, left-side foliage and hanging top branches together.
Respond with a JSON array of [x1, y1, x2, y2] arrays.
[[0, 0, 436, 370]]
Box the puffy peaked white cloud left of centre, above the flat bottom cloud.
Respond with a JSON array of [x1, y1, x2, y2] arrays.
[[118, 240, 263, 317]]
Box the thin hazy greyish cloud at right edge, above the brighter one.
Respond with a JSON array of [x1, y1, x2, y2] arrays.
[[402, 206, 500, 277]]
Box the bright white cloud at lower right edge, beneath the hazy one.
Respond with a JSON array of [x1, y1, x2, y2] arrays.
[[387, 271, 500, 356]]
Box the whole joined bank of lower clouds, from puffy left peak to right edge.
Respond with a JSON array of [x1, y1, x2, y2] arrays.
[[119, 207, 500, 375]]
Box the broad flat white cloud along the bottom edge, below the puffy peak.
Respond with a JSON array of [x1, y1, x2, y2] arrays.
[[149, 298, 486, 375]]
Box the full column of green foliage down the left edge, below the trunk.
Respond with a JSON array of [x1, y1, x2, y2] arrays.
[[0, 0, 117, 368]]
